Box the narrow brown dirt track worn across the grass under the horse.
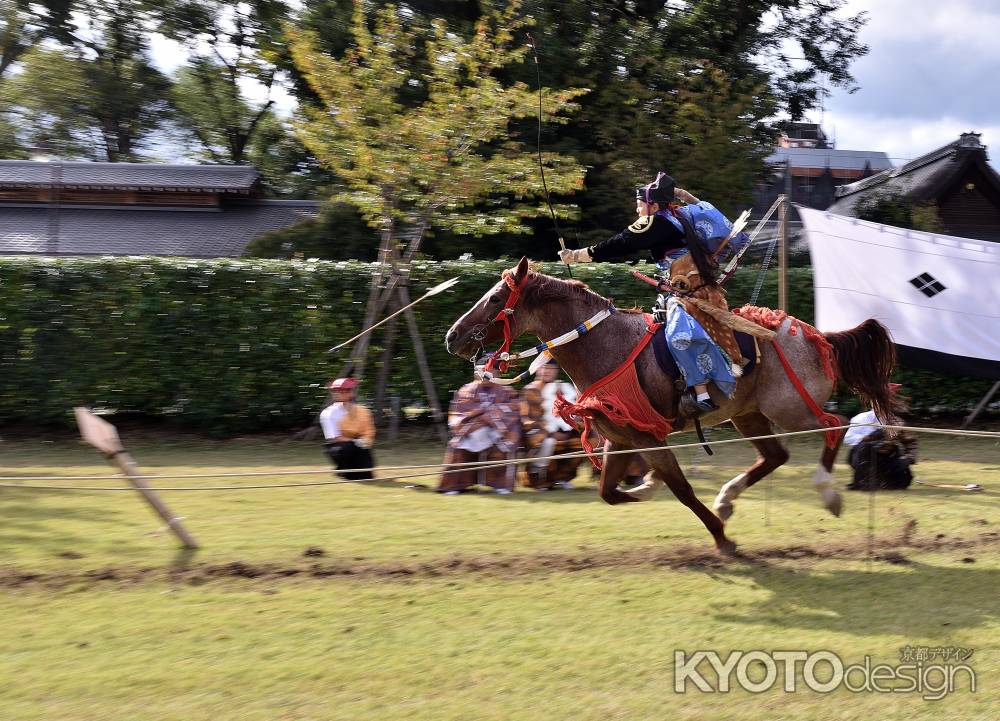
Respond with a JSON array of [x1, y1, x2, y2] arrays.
[[0, 521, 1000, 589]]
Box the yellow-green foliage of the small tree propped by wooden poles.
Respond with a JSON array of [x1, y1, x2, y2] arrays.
[[286, 2, 583, 236]]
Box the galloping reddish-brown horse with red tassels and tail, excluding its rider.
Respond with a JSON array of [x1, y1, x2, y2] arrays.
[[445, 258, 898, 553]]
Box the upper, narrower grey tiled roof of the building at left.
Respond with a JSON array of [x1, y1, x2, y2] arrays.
[[0, 160, 260, 194]]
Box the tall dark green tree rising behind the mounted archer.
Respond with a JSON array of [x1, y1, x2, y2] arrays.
[[500, 0, 867, 243]]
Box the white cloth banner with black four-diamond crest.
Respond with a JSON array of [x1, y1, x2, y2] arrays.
[[798, 207, 1000, 375]]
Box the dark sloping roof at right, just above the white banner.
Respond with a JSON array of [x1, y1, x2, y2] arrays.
[[827, 133, 1000, 215]]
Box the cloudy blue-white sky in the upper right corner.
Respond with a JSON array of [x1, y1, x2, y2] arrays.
[[810, 0, 1000, 167]]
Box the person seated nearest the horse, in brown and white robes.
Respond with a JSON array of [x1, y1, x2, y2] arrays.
[[521, 359, 587, 491]]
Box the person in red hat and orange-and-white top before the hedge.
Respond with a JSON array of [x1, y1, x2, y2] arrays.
[[319, 378, 375, 480]]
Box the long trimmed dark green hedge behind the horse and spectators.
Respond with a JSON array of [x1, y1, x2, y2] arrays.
[[0, 258, 989, 435]]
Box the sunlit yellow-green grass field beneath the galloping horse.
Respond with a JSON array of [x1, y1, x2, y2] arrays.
[[0, 424, 1000, 721]]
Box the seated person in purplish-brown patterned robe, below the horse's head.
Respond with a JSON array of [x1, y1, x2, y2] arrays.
[[437, 358, 521, 496]]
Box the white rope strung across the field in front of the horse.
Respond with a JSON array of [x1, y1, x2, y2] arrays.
[[0, 423, 1000, 492]]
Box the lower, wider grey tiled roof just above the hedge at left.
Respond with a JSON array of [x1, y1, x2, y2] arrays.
[[0, 200, 319, 258]]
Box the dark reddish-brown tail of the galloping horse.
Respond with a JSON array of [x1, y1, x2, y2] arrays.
[[823, 318, 905, 424]]
